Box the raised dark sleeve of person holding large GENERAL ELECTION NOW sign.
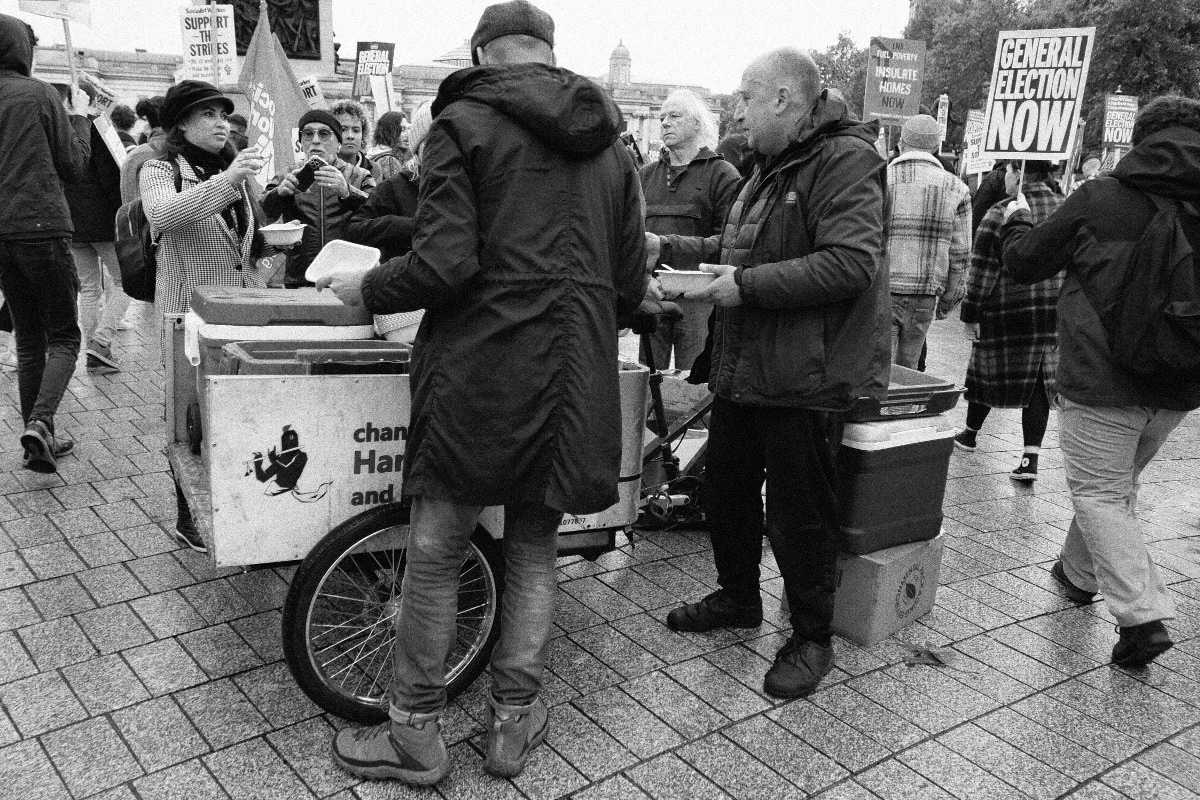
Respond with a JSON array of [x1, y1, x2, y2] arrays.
[[1000, 184, 1091, 283]]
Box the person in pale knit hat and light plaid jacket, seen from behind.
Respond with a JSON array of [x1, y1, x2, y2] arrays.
[[883, 114, 971, 369]]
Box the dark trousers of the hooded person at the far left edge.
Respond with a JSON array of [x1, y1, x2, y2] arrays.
[[0, 239, 79, 432]]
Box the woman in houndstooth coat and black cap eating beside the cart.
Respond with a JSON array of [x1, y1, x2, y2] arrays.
[[139, 80, 265, 553]]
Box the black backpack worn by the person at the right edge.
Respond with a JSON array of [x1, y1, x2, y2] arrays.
[[1084, 193, 1200, 381]]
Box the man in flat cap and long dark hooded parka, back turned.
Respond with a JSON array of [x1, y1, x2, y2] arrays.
[[318, 0, 647, 784]]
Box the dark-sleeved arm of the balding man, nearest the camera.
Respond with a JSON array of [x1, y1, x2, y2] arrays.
[[739, 146, 887, 308]]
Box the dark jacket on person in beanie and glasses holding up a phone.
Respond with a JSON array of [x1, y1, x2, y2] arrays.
[[262, 158, 374, 287]]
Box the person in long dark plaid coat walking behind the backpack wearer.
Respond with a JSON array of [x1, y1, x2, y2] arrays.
[[954, 161, 1063, 482]]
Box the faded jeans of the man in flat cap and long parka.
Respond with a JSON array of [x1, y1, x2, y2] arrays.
[[389, 498, 563, 720]]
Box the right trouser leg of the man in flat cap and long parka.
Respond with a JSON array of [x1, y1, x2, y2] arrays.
[[492, 504, 563, 706]]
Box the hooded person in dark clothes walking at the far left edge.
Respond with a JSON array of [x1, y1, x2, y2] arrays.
[[0, 14, 91, 473]]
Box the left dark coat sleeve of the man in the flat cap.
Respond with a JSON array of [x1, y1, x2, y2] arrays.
[[362, 125, 480, 314]]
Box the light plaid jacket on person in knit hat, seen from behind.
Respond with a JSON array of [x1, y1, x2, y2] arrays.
[[883, 152, 971, 311]]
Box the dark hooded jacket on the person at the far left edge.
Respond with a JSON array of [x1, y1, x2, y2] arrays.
[[0, 14, 91, 239]]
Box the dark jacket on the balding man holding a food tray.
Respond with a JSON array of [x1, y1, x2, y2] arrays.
[[666, 90, 892, 411]]
